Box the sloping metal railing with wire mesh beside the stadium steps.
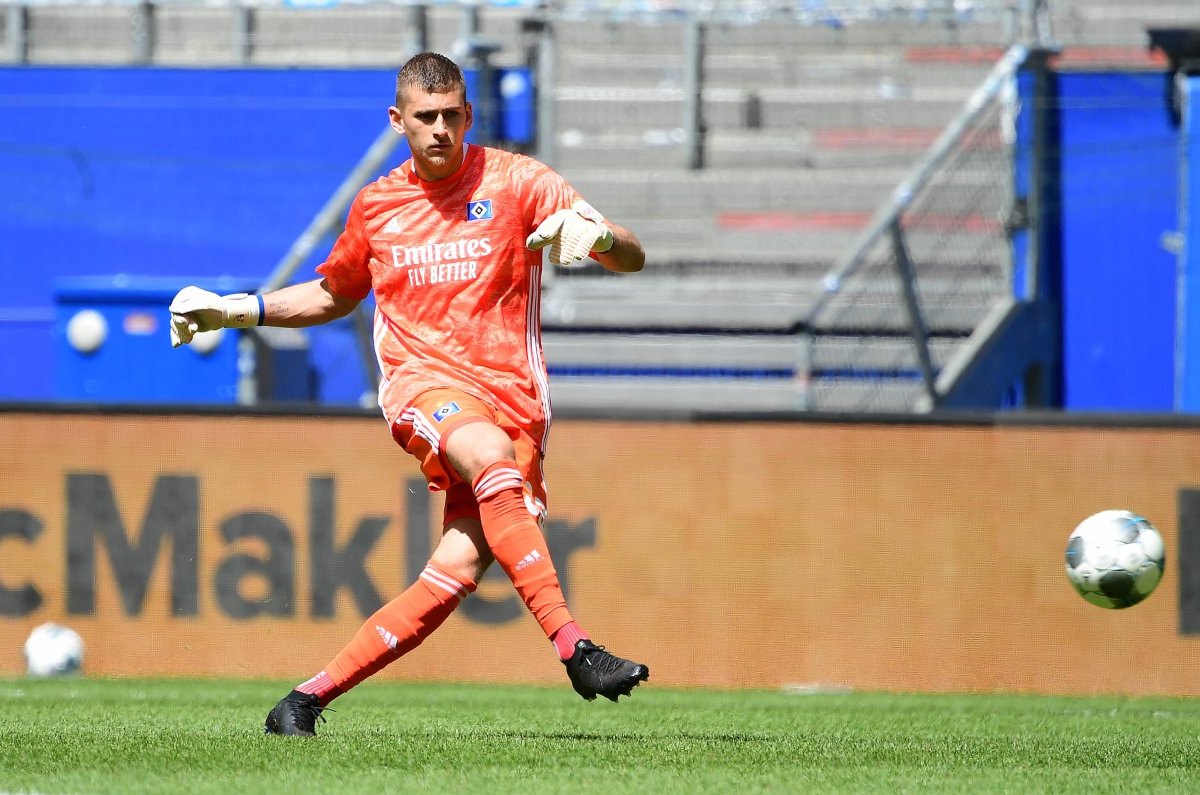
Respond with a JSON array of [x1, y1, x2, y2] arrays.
[[797, 44, 1030, 408]]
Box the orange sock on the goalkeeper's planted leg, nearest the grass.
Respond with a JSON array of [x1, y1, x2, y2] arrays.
[[314, 563, 475, 704]]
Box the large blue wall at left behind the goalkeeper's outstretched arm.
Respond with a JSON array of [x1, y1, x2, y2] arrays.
[[0, 67, 407, 401]]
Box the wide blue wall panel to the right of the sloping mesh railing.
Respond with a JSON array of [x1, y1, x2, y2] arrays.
[[1058, 72, 1180, 412]]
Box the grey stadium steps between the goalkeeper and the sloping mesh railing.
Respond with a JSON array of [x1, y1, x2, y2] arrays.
[[544, 15, 1022, 411]]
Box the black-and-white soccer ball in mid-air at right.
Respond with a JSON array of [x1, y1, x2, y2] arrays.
[[1067, 510, 1166, 610]]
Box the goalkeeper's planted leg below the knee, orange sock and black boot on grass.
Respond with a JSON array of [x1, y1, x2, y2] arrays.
[[265, 518, 492, 736]]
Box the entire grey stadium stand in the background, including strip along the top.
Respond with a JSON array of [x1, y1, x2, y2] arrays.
[[4, 0, 1195, 411]]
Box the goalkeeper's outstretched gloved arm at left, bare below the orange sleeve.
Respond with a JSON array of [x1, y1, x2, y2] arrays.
[[170, 279, 359, 348]]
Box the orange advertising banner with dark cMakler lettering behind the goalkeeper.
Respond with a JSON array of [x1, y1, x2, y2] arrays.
[[0, 411, 1200, 695]]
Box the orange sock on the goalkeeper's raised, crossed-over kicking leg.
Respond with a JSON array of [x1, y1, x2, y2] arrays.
[[470, 461, 572, 638]]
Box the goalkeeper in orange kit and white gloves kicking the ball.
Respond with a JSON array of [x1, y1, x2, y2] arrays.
[[170, 53, 649, 736]]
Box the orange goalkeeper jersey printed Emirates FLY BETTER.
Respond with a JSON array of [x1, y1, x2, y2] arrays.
[[317, 145, 580, 449]]
